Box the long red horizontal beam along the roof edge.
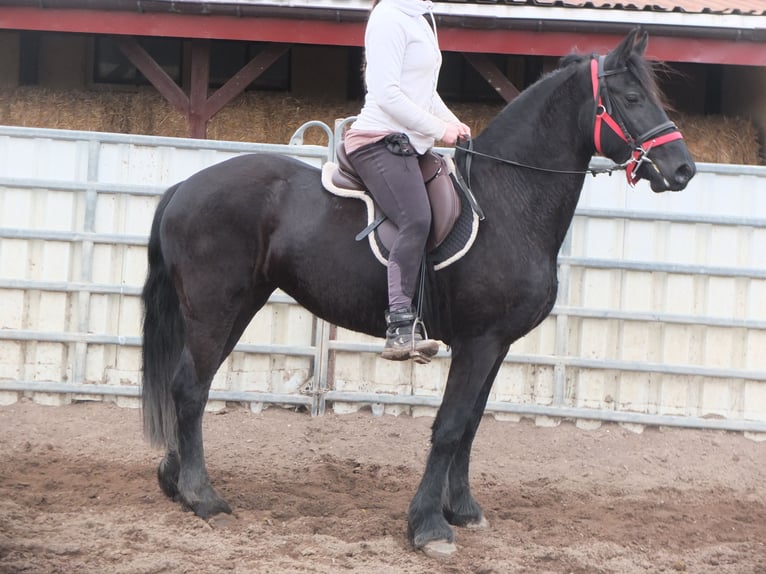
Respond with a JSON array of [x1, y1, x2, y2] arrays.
[[0, 7, 766, 66]]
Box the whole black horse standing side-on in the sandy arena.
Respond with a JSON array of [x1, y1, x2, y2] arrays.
[[142, 30, 695, 554]]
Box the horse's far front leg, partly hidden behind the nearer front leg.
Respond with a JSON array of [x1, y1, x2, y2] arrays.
[[443, 354, 508, 528]]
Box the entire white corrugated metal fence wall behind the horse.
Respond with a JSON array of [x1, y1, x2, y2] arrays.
[[0, 124, 766, 430]]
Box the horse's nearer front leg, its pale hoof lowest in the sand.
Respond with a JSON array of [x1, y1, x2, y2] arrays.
[[408, 336, 508, 556]]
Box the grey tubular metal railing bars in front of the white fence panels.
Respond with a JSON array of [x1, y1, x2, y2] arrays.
[[0, 126, 766, 432]]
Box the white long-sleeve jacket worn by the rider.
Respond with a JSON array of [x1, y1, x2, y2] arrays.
[[351, 0, 458, 153]]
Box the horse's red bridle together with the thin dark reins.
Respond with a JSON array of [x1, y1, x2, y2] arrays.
[[455, 56, 683, 187]]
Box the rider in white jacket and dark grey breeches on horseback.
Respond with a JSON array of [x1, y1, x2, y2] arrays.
[[344, 0, 471, 360]]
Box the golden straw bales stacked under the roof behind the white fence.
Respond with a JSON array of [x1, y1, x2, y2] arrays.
[[0, 87, 761, 165]]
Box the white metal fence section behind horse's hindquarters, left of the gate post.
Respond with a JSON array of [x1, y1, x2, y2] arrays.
[[0, 128, 328, 412]]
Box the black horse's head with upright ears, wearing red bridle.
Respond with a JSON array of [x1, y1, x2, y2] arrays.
[[591, 28, 696, 193]]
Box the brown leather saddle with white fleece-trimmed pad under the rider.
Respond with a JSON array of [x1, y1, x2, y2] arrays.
[[322, 142, 486, 270]]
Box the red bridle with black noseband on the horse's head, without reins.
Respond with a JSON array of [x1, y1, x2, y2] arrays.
[[590, 56, 683, 186]]
